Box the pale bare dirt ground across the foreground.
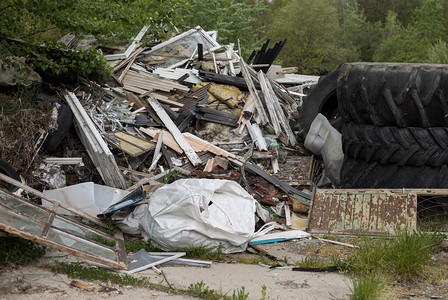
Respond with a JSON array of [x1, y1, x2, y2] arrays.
[[0, 240, 448, 300]]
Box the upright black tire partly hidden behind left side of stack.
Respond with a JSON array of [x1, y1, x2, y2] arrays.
[[296, 68, 342, 139]]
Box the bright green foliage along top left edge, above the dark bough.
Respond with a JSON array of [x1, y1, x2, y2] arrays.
[[0, 0, 186, 43]]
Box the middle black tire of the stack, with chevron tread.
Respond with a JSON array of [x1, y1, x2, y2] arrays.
[[342, 123, 448, 167]]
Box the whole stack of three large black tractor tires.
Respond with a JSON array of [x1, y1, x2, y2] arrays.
[[337, 63, 448, 188]]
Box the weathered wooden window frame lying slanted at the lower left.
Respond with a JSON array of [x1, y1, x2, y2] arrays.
[[0, 174, 127, 270]]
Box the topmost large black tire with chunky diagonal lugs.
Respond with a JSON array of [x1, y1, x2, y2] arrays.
[[337, 63, 448, 128]]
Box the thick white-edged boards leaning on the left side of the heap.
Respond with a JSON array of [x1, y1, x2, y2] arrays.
[[65, 91, 126, 189]]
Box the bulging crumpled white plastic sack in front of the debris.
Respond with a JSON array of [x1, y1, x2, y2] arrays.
[[140, 179, 255, 253]]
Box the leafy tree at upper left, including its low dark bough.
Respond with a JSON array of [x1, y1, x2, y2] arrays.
[[0, 0, 185, 81]]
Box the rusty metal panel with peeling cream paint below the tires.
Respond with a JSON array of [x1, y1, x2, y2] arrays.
[[307, 189, 417, 234]]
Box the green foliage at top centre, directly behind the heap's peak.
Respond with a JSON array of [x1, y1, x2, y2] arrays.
[[183, 0, 264, 57]]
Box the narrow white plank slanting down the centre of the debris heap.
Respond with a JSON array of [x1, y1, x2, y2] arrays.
[[146, 95, 202, 166]]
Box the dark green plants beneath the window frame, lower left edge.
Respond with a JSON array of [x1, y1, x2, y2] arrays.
[[0, 237, 45, 268]]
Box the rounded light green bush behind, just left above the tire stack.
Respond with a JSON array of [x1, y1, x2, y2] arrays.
[[268, 0, 358, 74]]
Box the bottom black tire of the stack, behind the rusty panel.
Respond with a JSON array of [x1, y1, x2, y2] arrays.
[[340, 157, 448, 189]]
